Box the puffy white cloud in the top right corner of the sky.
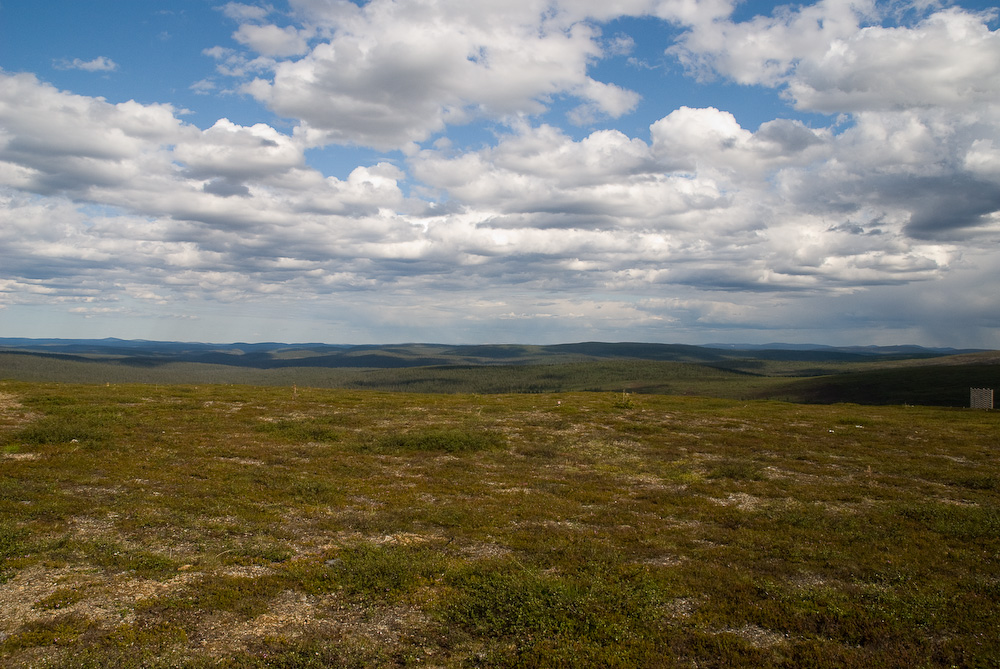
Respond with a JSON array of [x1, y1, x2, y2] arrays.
[[668, 0, 1000, 113]]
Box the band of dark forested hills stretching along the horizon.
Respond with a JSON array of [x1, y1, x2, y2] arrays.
[[0, 338, 1000, 406]]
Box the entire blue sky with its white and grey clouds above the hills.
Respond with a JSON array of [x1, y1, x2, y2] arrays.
[[0, 0, 1000, 348]]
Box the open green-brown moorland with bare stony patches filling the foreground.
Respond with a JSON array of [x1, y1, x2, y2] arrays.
[[0, 374, 1000, 668]]
